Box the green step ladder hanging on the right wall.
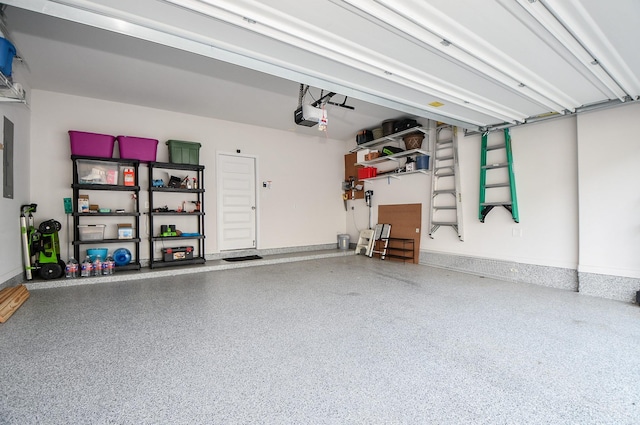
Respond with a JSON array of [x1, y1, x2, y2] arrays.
[[478, 128, 520, 223]]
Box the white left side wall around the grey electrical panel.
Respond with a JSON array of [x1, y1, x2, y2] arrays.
[[0, 66, 32, 284]]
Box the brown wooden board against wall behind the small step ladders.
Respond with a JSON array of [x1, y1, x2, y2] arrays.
[[378, 204, 422, 264]]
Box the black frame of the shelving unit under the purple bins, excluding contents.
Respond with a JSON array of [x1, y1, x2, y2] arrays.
[[71, 155, 140, 271]]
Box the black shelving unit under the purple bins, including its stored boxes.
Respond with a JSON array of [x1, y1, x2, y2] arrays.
[[71, 155, 140, 270]]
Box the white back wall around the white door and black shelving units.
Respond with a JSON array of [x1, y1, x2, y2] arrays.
[[30, 91, 345, 259]]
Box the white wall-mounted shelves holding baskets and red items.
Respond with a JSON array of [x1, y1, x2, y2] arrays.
[[352, 127, 430, 181]]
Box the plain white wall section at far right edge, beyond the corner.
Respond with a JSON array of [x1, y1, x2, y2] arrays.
[[578, 103, 640, 278]]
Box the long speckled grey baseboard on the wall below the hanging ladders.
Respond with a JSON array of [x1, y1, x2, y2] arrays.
[[420, 251, 578, 292]]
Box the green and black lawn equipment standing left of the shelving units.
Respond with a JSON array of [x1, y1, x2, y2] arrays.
[[20, 204, 65, 280]]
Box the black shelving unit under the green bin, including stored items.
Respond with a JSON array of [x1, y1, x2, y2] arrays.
[[147, 159, 206, 268]]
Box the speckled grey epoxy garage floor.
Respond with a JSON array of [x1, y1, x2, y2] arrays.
[[0, 256, 640, 424]]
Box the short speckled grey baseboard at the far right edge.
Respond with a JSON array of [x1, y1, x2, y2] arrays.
[[578, 272, 640, 303]]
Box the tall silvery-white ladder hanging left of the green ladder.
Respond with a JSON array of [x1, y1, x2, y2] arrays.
[[429, 121, 464, 241]]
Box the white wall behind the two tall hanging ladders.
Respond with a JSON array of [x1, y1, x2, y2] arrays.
[[347, 118, 578, 269]]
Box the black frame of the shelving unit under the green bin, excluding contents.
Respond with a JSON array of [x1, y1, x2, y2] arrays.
[[147, 162, 206, 269]]
